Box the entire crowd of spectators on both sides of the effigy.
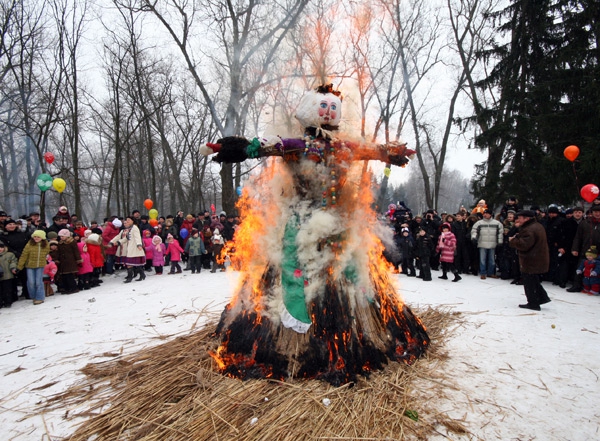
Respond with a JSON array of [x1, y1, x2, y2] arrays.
[[0, 197, 600, 307]]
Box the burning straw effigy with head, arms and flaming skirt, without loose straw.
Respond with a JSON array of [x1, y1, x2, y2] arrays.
[[201, 85, 429, 385]]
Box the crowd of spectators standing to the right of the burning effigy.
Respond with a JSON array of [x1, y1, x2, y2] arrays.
[[386, 197, 600, 295]]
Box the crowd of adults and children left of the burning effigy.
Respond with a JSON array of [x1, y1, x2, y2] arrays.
[[0, 206, 240, 307]]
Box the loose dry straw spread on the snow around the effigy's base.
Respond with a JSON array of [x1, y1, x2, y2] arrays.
[[45, 310, 466, 441]]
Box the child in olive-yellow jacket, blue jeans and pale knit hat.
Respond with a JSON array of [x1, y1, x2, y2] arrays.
[[17, 230, 50, 305]]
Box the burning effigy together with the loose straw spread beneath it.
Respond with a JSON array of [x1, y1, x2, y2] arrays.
[[30, 86, 466, 441]]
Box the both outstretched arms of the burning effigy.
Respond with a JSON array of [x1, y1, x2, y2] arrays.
[[200, 136, 416, 167]]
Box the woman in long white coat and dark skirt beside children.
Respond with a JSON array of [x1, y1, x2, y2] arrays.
[[109, 216, 146, 283]]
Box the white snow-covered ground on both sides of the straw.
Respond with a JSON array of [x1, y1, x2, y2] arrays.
[[0, 271, 600, 441]]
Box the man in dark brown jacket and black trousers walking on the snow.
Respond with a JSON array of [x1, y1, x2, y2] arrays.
[[508, 210, 550, 311]]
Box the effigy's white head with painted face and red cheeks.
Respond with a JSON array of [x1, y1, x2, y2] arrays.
[[296, 91, 342, 127]]
